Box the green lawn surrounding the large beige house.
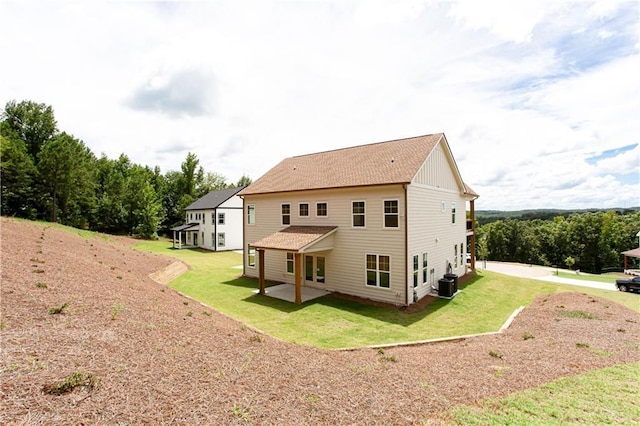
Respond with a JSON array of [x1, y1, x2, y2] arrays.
[[135, 241, 640, 348]]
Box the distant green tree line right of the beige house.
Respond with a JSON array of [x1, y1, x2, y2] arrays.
[[476, 210, 640, 273]]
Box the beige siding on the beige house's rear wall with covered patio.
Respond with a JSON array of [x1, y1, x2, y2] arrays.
[[244, 185, 407, 304]]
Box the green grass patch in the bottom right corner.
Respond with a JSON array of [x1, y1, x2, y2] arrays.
[[449, 363, 640, 425]]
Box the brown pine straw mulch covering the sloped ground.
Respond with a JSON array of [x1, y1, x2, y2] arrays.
[[0, 218, 640, 425]]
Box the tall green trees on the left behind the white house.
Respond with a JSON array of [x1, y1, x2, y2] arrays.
[[0, 101, 251, 238]]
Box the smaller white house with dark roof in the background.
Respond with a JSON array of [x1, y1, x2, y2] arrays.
[[171, 186, 245, 251]]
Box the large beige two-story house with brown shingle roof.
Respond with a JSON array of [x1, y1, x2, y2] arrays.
[[239, 133, 478, 305]]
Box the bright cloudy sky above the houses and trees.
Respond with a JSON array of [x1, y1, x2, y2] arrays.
[[0, 0, 640, 210]]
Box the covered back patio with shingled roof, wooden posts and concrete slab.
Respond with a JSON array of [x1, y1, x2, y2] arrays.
[[252, 226, 338, 304]]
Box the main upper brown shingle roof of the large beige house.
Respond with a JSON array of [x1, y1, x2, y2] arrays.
[[239, 133, 444, 195]]
